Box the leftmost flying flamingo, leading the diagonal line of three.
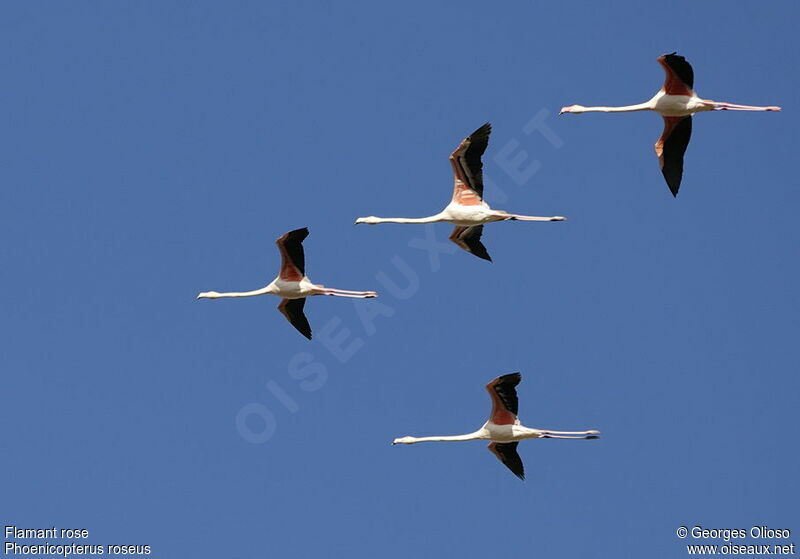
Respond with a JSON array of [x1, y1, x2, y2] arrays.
[[197, 227, 378, 340]]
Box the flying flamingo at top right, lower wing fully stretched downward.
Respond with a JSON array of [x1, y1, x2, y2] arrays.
[[559, 52, 781, 196]]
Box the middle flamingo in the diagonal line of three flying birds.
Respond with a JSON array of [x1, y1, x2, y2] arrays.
[[356, 122, 566, 262]]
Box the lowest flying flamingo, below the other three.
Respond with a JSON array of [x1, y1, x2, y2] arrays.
[[392, 373, 600, 480]]
